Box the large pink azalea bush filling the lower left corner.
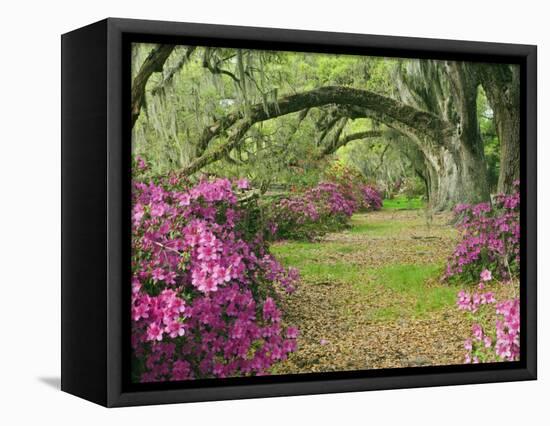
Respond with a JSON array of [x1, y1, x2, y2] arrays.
[[131, 159, 299, 382]]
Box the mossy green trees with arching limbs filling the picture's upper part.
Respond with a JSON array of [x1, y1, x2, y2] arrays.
[[131, 44, 519, 209]]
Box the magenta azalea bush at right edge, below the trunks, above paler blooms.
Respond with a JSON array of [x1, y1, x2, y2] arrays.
[[446, 182, 520, 282]]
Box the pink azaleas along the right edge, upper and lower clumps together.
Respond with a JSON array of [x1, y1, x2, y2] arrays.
[[452, 182, 520, 363]]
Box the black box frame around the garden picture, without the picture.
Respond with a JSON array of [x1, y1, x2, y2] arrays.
[[61, 18, 537, 407]]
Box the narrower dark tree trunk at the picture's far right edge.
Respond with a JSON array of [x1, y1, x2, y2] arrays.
[[479, 64, 520, 193]]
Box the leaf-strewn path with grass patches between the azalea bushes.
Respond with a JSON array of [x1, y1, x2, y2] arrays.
[[272, 201, 470, 374]]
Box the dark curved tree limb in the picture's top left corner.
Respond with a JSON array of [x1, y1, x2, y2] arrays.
[[131, 44, 175, 128]]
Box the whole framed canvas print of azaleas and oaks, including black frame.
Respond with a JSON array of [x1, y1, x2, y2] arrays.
[[62, 19, 536, 406]]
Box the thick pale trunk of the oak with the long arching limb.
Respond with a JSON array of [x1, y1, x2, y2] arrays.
[[397, 61, 490, 210]]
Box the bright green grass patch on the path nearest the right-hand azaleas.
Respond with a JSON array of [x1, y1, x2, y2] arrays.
[[357, 264, 457, 319]]
